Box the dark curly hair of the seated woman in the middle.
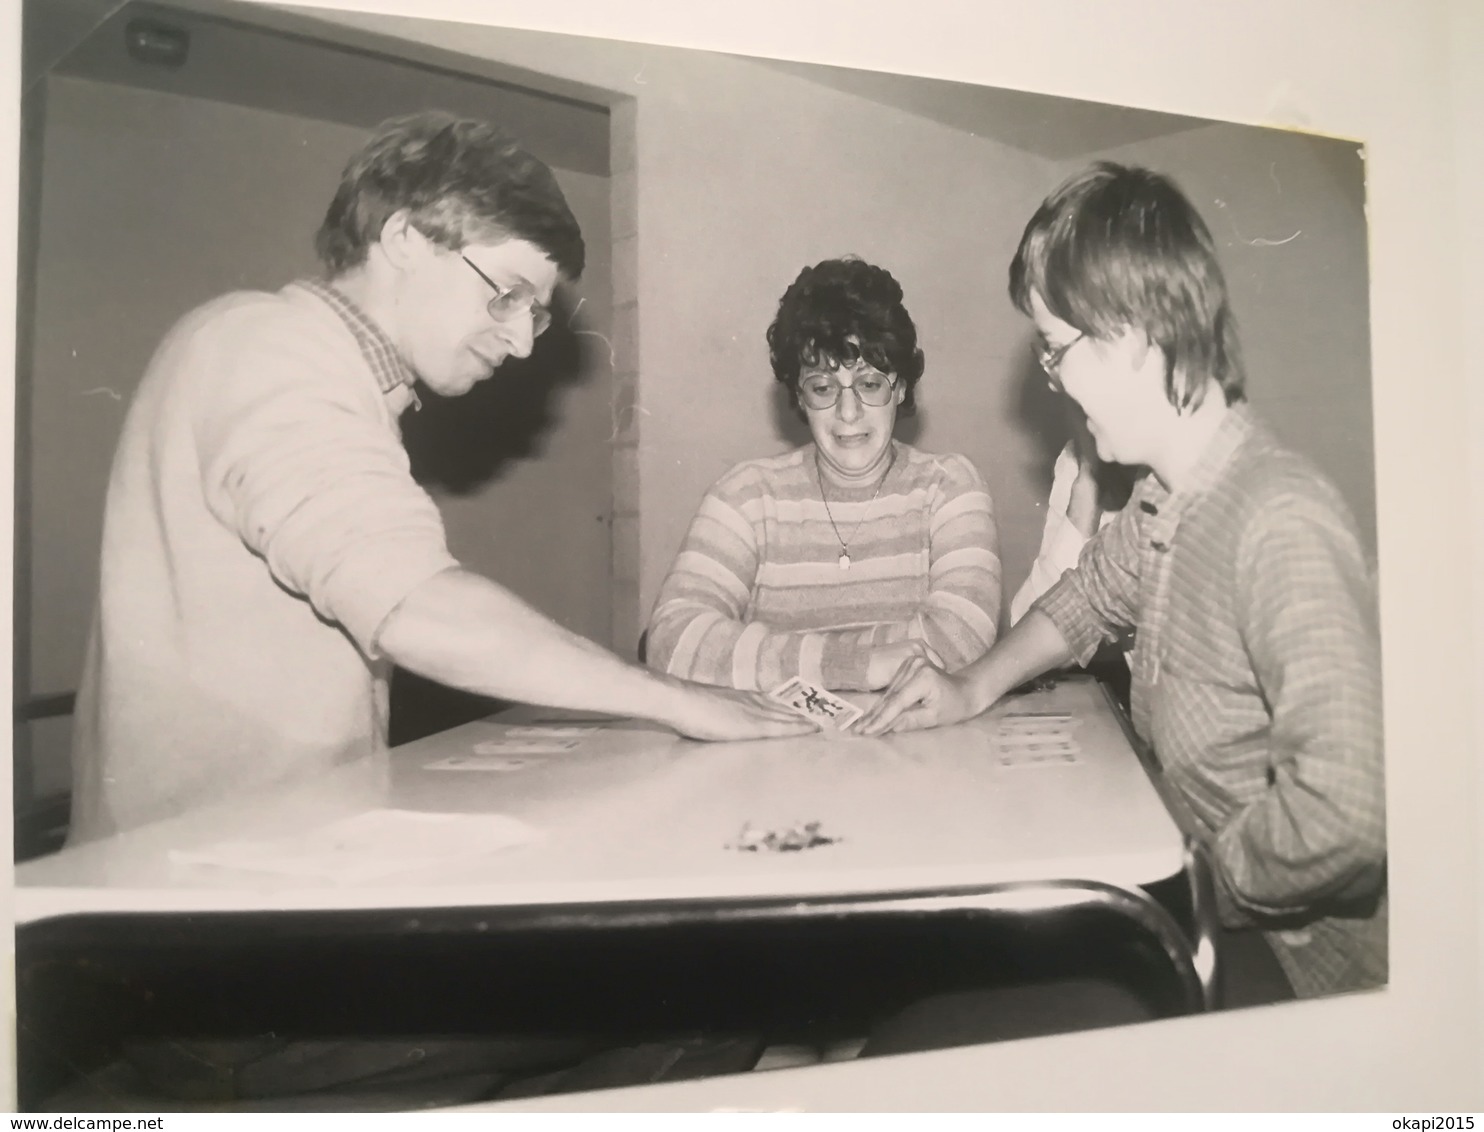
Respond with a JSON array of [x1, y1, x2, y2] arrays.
[[767, 255, 923, 415]]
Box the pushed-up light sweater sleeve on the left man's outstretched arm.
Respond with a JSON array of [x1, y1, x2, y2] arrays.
[[187, 303, 457, 656]]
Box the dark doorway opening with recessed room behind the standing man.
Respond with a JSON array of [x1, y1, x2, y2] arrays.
[[13, 0, 623, 858]]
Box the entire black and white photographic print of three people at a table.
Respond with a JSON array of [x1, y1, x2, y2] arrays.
[[12, 0, 1472, 1113]]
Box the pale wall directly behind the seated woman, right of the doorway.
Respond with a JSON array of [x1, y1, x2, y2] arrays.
[[276, 12, 1064, 637]]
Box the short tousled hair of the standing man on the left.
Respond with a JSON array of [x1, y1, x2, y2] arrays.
[[315, 110, 586, 280]]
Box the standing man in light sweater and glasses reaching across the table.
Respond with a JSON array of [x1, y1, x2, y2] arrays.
[[71, 114, 809, 843]]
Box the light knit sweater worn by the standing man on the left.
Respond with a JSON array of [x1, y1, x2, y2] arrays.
[[71, 285, 456, 843]]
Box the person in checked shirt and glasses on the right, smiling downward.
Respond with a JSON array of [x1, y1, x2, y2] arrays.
[[856, 163, 1386, 997]]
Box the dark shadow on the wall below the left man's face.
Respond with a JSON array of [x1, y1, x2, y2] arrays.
[[402, 292, 586, 496]]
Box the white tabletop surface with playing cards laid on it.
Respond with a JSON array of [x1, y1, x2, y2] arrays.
[[15, 678, 1183, 923]]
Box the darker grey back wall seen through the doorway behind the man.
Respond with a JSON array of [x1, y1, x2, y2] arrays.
[[18, 77, 611, 794]]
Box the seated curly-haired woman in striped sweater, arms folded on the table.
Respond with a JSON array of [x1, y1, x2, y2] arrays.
[[647, 258, 1000, 691]]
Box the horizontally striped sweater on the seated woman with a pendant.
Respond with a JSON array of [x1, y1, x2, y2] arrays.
[[649, 444, 1000, 691]]
